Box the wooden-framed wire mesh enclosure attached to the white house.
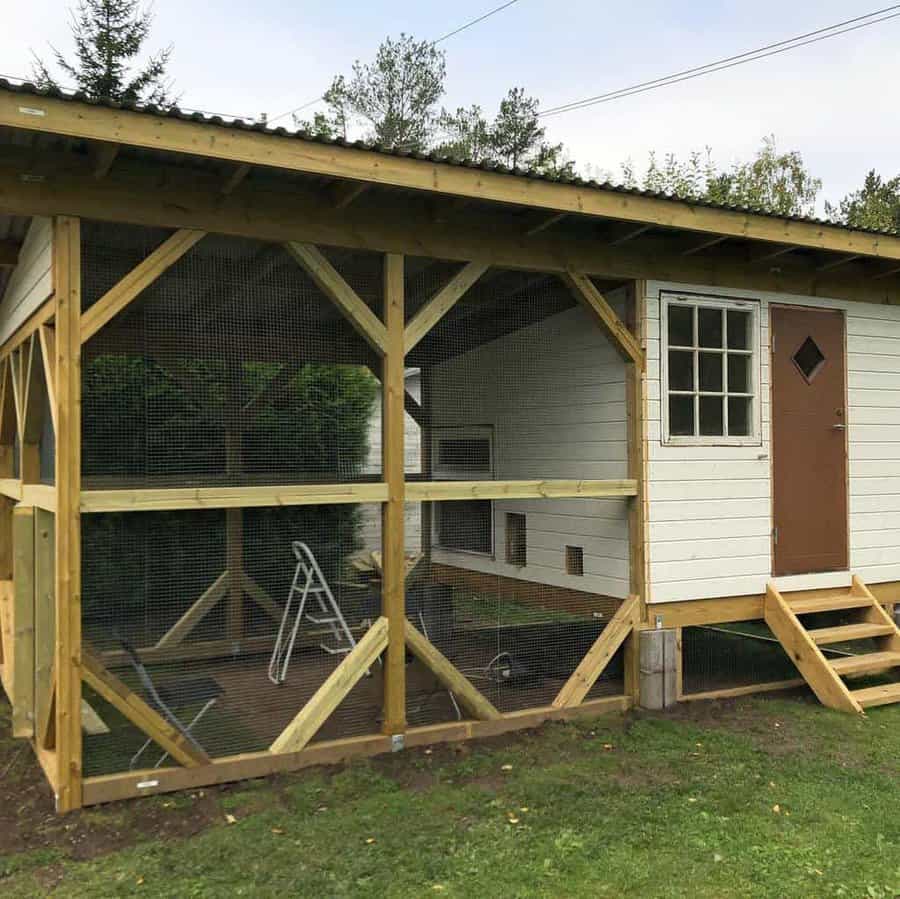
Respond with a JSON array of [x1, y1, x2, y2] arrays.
[[3, 220, 639, 808]]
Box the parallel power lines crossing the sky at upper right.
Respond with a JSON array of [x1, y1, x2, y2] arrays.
[[539, 4, 900, 117]]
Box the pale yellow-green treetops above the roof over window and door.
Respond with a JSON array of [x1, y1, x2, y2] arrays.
[[622, 136, 822, 215]]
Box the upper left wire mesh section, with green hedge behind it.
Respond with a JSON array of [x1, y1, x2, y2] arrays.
[[82, 225, 382, 488]]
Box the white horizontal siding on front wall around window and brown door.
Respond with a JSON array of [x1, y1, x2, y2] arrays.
[[646, 282, 900, 602]]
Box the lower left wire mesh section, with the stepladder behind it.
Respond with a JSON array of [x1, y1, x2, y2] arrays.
[[82, 505, 381, 774]]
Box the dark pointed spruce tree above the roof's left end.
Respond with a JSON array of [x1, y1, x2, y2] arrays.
[[34, 0, 174, 106]]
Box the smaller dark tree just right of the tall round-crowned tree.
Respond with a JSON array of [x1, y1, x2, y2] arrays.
[[435, 87, 574, 176]]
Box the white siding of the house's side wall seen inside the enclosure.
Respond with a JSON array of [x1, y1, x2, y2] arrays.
[[432, 296, 628, 597]]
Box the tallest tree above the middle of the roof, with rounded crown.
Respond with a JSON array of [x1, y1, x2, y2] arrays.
[[306, 34, 446, 150]]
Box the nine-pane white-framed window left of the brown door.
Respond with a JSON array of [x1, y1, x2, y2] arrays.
[[660, 293, 760, 446]]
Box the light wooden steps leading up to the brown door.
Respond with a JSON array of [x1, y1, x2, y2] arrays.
[[764, 576, 900, 714]]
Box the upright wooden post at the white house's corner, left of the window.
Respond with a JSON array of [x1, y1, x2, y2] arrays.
[[625, 281, 648, 704]]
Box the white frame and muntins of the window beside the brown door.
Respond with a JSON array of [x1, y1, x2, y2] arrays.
[[659, 291, 762, 446]]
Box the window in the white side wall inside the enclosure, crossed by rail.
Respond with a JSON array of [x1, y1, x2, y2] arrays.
[[432, 427, 494, 556]]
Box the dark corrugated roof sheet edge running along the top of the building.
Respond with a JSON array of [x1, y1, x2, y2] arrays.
[[0, 78, 898, 237]]
